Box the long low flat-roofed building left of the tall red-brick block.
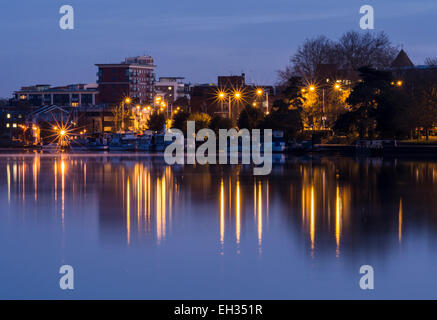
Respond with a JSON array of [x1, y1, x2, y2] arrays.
[[14, 84, 98, 107]]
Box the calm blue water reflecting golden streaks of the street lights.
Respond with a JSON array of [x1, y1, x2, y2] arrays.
[[0, 154, 437, 299]]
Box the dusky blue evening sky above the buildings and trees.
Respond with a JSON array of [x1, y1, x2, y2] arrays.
[[0, 0, 437, 97]]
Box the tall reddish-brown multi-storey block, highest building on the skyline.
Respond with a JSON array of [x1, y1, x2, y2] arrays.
[[96, 56, 156, 105]]
